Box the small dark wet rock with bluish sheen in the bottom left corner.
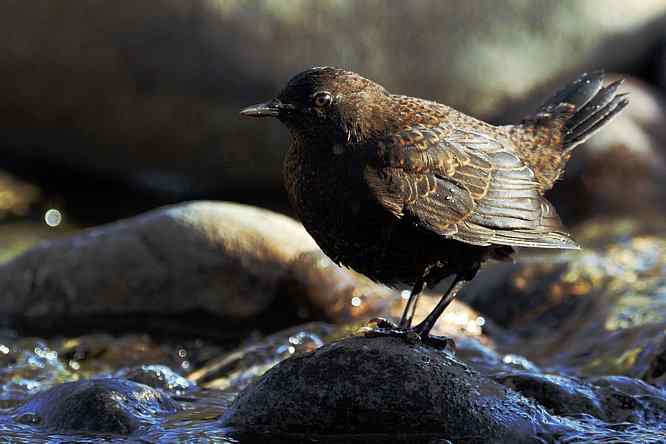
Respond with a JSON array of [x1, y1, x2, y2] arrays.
[[12, 379, 178, 435]]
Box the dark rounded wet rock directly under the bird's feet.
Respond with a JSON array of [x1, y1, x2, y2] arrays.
[[224, 337, 560, 443]]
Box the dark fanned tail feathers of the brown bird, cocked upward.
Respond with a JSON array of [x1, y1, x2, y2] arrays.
[[529, 71, 629, 151]]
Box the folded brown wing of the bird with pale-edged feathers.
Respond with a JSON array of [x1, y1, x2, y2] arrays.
[[365, 123, 578, 248]]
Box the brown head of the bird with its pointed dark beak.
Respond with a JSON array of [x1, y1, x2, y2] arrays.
[[241, 67, 391, 142]]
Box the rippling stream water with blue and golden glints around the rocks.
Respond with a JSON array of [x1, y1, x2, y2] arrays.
[[0, 217, 666, 444]]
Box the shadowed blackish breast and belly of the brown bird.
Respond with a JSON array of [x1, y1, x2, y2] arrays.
[[284, 142, 487, 286]]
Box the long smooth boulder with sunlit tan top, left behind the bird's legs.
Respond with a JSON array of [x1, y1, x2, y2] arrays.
[[0, 202, 390, 336]]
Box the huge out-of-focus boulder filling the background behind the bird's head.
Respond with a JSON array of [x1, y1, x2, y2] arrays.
[[0, 0, 664, 201]]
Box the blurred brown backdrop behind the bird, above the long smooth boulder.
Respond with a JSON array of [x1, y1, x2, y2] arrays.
[[0, 0, 666, 250]]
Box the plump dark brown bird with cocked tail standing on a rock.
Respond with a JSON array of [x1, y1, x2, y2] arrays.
[[241, 66, 629, 345]]
